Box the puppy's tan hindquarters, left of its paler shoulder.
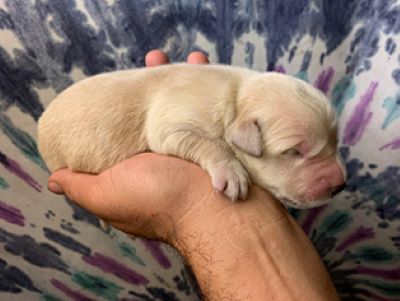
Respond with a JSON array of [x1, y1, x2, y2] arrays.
[[38, 70, 153, 173]]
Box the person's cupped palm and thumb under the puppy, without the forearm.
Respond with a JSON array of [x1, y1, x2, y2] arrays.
[[48, 153, 214, 239]]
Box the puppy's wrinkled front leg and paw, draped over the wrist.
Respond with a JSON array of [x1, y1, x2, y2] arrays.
[[148, 124, 250, 201]]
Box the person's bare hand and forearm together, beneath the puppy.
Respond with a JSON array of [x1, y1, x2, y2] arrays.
[[50, 154, 338, 301]]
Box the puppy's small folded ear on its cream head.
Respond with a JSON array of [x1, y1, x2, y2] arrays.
[[231, 120, 262, 158]]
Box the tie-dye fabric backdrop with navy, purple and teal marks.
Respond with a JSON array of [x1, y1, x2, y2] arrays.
[[0, 0, 400, 301]]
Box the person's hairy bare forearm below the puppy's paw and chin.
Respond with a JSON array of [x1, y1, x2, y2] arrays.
[[175, 187, 339, 301]]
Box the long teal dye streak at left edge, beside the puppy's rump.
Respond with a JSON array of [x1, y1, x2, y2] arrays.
[[0, 113, 47, 171]]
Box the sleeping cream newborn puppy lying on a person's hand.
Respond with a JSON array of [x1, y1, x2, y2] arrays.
[[38, 64, 346, 208]]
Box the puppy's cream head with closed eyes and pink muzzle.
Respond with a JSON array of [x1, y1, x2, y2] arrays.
[[228, 73, 346, 208]]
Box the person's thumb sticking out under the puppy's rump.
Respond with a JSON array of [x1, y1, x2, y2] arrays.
[[47, 169, 107, 216]]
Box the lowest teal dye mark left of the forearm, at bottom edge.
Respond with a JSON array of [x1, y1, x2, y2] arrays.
[[72, 272, 123, 301]]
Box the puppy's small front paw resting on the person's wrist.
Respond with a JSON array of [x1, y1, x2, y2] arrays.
[[208, 160, 250, 201]]
